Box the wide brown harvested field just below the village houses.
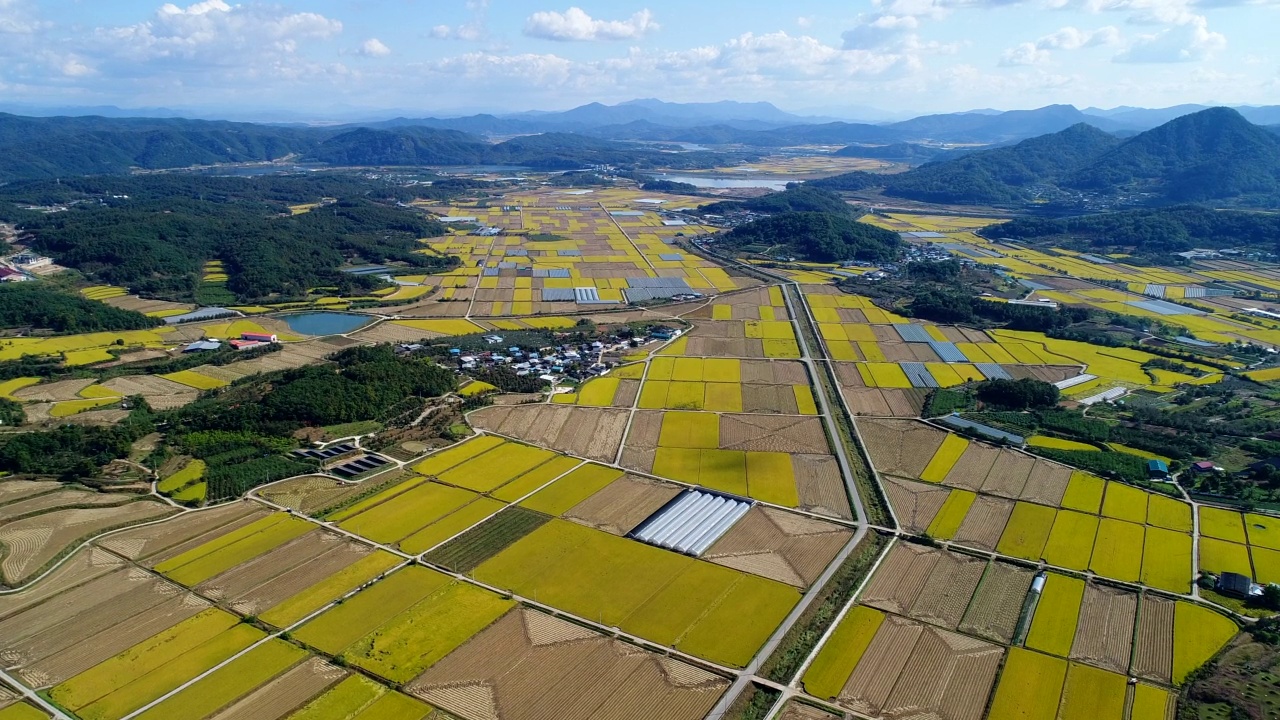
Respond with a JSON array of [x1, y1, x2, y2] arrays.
[[468, 404, 630, 462]]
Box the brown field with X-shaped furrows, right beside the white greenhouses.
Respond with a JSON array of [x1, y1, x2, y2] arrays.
[[703, 506, 852, 588]]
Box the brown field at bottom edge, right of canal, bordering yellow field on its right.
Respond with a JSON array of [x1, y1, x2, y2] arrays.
[[881, 628, 1005, 720]]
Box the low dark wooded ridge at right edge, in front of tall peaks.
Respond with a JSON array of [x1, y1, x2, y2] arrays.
[[980, 206, 1280, 255]]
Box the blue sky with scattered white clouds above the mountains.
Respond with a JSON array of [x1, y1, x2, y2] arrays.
[[0, 0, 1280, 119]]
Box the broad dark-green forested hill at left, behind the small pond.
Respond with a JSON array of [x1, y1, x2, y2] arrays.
[[0, 174, 456, 304]]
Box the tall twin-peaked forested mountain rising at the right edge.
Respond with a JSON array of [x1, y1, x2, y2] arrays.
[[812, 108, 1280, 206]]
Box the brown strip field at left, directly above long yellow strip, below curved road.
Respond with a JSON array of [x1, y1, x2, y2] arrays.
[[97, 500, 270, 566]]
